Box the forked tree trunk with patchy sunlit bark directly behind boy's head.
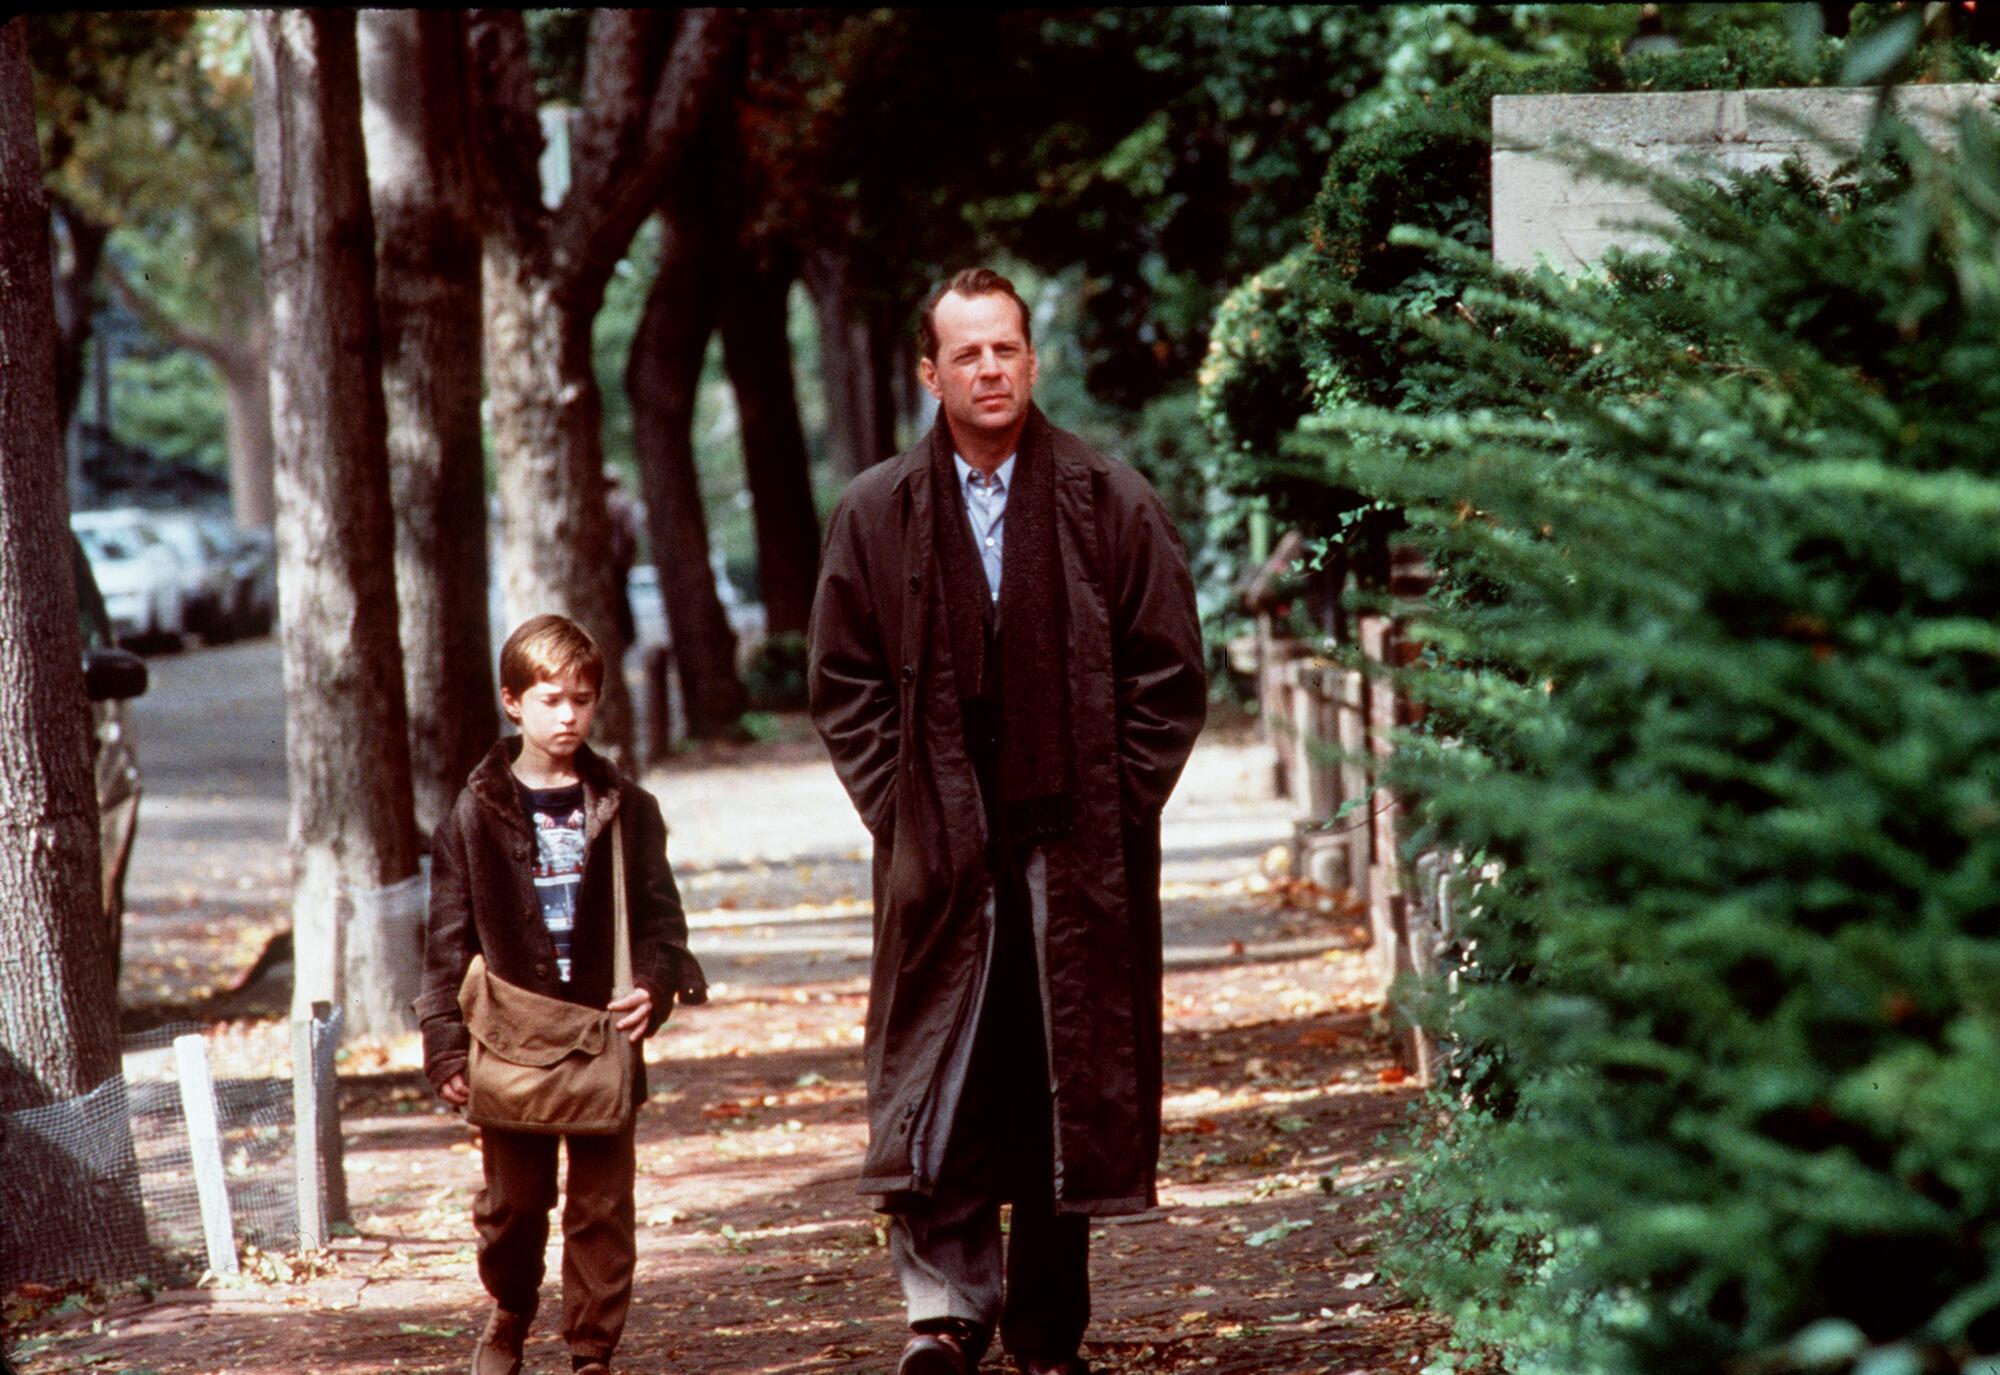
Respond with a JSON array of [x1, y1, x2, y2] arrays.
[[470, 10, 738, 753]]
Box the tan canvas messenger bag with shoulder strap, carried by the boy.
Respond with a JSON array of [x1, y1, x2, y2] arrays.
[[458, 815, 638, 1137]]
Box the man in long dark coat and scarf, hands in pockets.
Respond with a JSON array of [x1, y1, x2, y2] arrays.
[[810, 270, 1206, 1375]]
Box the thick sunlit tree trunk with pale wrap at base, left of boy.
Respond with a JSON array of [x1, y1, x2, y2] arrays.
[[250, 10, 420, 1033]]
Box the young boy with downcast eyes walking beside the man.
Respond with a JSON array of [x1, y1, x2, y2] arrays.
[[416, 616, 708, 1375]]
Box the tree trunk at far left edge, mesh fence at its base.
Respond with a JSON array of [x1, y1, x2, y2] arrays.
[[0, 20, 146, 1281]]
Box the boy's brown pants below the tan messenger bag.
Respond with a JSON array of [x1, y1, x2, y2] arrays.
[[472, 1123, 638, 1363]]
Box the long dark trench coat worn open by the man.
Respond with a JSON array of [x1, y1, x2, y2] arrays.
[[810, 412, 1208, 1215]]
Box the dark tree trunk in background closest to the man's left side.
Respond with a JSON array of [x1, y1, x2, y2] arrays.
[[722, 262, 820, 636]]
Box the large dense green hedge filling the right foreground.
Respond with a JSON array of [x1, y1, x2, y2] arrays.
[[1290, 107, 2000, 1375]]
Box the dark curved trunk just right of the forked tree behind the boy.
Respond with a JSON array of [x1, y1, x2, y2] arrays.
[[626, 212, 748, 739]]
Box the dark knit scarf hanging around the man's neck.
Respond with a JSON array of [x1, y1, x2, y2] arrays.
[[930, 410, 1074, 845]]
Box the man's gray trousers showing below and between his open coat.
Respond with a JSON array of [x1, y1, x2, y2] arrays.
[[888, 855, 1090, 1361]]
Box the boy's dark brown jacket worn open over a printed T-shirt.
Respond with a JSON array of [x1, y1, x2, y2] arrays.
[[414, 737, 708, 1099]]
